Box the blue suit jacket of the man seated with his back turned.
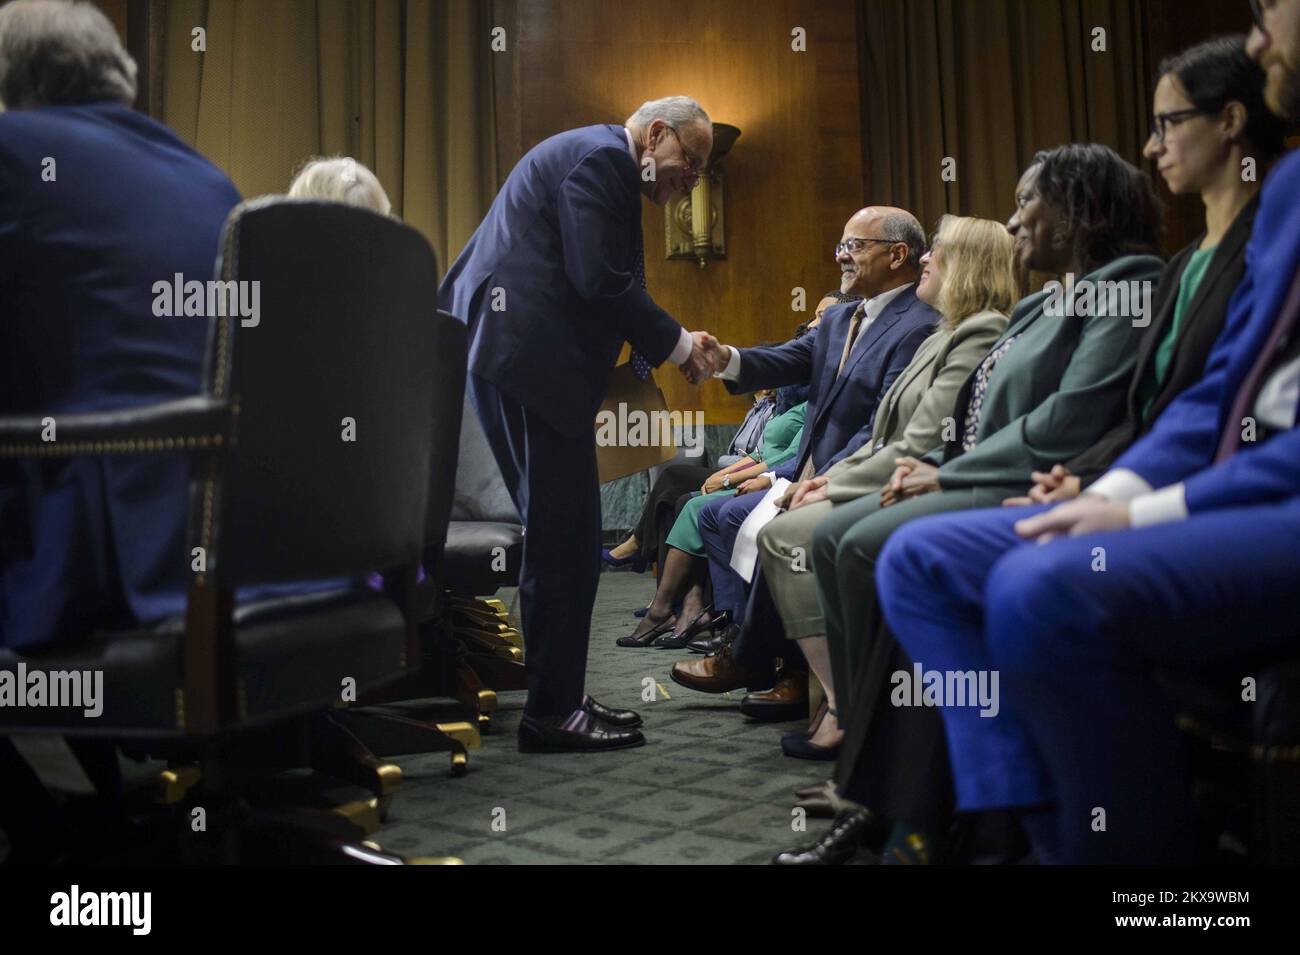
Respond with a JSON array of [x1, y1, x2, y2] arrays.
[[0, 104, 239, 648]]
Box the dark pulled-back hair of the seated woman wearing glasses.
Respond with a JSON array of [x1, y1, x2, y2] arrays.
[[1156, 34, 1286, 161]]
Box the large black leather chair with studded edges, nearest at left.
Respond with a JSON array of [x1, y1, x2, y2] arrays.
[[0, 199, 465, 861]]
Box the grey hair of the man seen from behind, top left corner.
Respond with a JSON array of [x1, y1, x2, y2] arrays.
[[0, 0, 135, 109]]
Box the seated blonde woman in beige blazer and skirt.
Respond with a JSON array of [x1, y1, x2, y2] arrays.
[[758, 216, 1019, 759]]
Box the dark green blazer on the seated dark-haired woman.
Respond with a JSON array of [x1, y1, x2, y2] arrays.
[[930, 256, 1164, 490]]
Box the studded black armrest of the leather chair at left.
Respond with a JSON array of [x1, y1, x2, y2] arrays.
[[0, 395, 230, 459]]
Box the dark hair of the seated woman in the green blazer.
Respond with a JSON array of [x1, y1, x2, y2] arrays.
[[1030, 143, 1161, 272]]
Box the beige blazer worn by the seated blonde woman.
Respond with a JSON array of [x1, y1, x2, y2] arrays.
[[826, 311, 1008, 503]]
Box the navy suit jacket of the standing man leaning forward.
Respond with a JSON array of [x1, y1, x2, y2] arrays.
[[438, 125, 681, 435]]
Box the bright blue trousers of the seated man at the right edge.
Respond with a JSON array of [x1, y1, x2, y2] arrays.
[[876, 500, 1300, 863]]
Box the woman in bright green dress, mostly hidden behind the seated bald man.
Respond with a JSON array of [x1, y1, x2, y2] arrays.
[[618, 401, 807, 648]]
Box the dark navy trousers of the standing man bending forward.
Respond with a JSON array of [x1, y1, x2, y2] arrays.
[[468, 374, 601, 717]]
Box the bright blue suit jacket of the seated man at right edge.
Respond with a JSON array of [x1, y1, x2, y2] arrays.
[[1114, 147, 1300, 513]]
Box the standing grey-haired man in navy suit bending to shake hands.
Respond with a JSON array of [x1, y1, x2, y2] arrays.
[[438, 96, 716, 752]]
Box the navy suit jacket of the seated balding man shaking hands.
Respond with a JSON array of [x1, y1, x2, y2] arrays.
[[725, 286, 940, 478]]
